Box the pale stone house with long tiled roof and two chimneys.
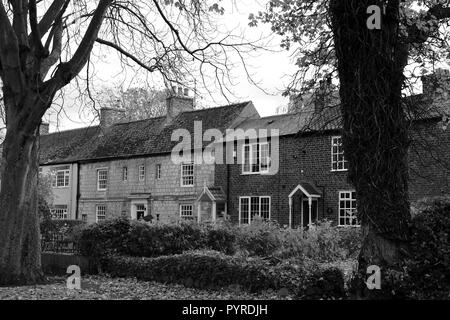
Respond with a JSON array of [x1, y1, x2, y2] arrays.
[[40, 91, 259, 223]]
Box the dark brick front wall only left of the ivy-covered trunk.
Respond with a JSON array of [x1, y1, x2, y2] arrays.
[[216, 135, 353, 226]]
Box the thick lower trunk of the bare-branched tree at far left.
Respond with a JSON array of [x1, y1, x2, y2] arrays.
[[0, 98, 43, 285]]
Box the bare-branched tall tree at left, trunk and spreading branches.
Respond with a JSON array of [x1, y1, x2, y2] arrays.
[[0, 0, 255, 284]]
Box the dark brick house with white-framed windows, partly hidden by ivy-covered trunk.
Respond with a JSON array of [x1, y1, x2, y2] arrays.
[[215, 73, 450, 228]]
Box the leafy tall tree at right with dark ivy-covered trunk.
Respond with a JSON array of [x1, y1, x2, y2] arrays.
[[255, 0, 450, 292]]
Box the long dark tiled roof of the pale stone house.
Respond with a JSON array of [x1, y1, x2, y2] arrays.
[[40, 102, 251, 164]]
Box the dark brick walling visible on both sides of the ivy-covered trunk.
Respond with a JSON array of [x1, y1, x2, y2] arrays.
[[220, 121, 450, 225]]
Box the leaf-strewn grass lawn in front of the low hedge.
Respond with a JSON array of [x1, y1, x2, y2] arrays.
[[0, 275, 293, 300]]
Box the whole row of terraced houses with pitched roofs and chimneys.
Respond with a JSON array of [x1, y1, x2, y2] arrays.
[[1, 72, 450, 228]]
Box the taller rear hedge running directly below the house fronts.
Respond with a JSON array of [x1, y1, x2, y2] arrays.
[[78, 218, 360, 262]]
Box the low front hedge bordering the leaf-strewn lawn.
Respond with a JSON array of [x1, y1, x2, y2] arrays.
[[97, 251, 345, 299]]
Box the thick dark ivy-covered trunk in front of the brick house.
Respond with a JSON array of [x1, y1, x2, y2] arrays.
[[330, 0, 410, 296]]
